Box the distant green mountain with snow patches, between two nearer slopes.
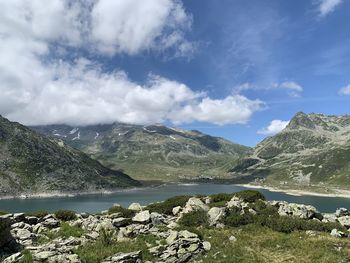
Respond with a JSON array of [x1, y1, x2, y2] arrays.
[[31, 123, 250, 181]]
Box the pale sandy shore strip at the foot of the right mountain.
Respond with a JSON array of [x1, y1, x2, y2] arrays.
[[237, 184, 350, 198]]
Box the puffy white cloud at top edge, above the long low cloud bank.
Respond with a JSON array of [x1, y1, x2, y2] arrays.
[[91, 0, 193, 56]]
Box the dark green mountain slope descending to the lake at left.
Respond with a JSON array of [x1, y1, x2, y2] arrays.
[[0, 116, 139, 195]]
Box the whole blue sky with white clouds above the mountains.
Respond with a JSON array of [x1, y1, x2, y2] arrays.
[[0, 0, 350, 146]]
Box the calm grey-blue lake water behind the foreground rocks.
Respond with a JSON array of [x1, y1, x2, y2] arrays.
[[0, 184, 350, 213]]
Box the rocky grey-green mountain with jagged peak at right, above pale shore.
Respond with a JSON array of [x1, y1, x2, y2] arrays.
[[231, 112, 350, 192]]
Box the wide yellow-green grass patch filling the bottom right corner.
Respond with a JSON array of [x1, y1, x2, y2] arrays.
[[197, 225, 350, 263]]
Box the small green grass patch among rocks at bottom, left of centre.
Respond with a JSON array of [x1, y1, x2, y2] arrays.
[[75, 235, 157, 263]]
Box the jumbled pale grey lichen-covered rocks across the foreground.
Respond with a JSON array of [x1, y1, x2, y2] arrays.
[[0, 192, 350, 263]]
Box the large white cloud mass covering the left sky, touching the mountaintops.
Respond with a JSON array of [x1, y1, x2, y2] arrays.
[[0, 0, 263, 125]]
